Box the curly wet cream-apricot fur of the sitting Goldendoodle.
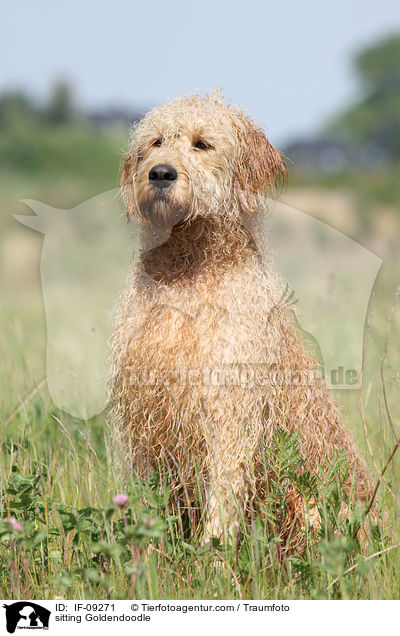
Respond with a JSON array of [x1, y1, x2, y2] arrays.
[[111, 89, 368, 543]]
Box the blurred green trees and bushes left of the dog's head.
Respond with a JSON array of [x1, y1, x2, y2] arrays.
[[0, 81, 145, 181]]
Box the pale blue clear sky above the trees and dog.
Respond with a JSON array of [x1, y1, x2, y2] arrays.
[[0, 0, 400, 143]]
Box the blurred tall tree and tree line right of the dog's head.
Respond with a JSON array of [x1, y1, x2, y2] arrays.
[[285, 35, 400, 174]]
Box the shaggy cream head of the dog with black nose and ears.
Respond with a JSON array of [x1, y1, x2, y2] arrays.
[[121, 96, 285, 229]]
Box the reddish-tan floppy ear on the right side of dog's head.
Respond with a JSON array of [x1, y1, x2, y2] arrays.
[[237, 120, 287, 207]]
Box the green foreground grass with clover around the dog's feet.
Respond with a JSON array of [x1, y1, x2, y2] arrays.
[[0, 358, 400, 599]]
